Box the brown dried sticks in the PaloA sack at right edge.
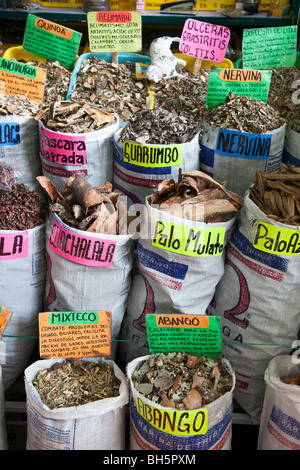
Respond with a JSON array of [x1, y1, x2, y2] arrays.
[[249, 163, 300, 226]]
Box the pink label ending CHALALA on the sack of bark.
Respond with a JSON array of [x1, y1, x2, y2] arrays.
[[48, 221, 116, 268]]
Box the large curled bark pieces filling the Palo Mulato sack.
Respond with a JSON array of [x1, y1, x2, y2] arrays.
[[148, 170, 243, 223]]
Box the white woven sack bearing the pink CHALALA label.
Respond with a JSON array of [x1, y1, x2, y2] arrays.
[[45, 213, 134, 357]]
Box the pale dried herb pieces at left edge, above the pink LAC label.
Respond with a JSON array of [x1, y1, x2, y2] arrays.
[[0, 94, 41, 117]]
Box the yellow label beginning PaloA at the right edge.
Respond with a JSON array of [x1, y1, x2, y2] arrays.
[[253, 222, 300, 256]]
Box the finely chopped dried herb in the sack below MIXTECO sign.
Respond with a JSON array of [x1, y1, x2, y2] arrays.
[[32, 360, 120, 410]]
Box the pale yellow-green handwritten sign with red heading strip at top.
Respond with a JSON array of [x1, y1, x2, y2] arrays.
[[87, 11, 142, 52]]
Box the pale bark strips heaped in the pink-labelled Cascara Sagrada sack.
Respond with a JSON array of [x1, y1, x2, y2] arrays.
[[36, 101, 116, 134]]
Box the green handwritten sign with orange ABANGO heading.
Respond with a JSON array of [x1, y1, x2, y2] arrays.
[[146, 314, 222, 357]]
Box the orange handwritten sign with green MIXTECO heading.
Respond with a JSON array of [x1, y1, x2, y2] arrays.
[[39, 311, 111, 359]]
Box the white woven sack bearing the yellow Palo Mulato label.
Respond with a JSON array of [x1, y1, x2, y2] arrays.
[[119, 201, 235, 363]]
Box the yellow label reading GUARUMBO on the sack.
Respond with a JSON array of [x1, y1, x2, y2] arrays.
[[123, 141, 182, 168]]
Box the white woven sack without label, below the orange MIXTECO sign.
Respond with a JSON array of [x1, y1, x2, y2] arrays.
[[24, 358, 128, 450]]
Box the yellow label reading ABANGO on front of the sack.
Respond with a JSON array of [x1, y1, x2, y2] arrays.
[[135, 396, 208, 436]]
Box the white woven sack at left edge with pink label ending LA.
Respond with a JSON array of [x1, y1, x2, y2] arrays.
[[0, 224, 47, 390]]
